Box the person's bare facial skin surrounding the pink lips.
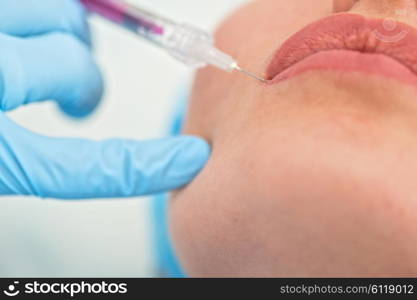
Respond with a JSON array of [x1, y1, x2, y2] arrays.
[[170, 0, 417, 277]]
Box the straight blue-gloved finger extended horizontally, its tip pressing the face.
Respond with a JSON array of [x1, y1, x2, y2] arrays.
[[0, 112, 210, 199]]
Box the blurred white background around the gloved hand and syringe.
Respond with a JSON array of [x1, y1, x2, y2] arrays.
[[0, 0, 245, 277]]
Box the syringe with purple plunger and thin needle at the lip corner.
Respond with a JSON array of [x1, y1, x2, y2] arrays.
[[81, 0, 266, 82]]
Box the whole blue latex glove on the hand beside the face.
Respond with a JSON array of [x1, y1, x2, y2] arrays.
[[0, 0, 210, 199]]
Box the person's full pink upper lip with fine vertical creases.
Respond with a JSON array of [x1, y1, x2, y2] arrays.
[[266, 13, 417, 80]]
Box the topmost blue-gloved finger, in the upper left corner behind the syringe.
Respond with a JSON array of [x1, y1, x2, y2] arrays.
[[0, 0, 90, 44]]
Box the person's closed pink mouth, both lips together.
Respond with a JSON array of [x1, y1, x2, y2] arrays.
[[266, 13, 417, 86]]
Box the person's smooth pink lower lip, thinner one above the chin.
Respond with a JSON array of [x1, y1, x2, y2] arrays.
[[269, 50, 417, 86]]
